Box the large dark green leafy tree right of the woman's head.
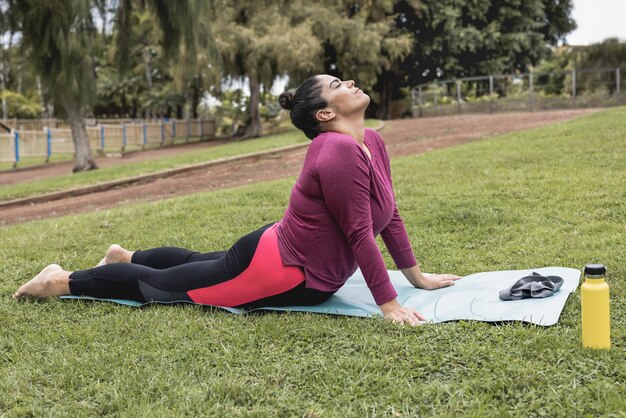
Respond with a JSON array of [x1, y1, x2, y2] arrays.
[[370, 0, 576, 117]]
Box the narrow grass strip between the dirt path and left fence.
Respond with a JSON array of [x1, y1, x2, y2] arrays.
[[0, 119, 380, 201]]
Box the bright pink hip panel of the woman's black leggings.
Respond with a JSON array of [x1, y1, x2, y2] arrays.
[[187, 223, 304, 307]]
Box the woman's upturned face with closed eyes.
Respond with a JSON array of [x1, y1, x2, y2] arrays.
[[318, 74, 370, 117]]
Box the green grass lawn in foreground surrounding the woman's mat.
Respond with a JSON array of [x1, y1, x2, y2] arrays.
[[0, 108, 626, 417]]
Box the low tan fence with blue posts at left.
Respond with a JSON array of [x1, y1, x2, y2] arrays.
[[0, 119, 216, 167]]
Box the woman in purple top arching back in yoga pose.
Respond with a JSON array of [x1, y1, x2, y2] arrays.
[[14, 75, 460, 325]]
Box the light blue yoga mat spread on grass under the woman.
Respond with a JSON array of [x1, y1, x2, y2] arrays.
[[61, 267, 581, 326]]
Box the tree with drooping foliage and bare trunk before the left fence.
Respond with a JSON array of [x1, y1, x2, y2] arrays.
[[9, 0, 201, 172]]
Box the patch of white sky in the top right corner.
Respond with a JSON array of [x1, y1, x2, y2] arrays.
[[566, 0, 626, 45]]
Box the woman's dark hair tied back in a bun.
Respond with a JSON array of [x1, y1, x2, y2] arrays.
[[278, 75, 328, 139]]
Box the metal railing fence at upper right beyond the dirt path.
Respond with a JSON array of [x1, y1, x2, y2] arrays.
[[411, 68, 626, 117]]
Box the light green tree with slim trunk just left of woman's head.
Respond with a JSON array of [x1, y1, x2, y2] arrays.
[[211, 0, 322, 138]]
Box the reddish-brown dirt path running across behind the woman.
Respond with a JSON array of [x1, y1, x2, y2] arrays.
[[0, 109, 598, 225]]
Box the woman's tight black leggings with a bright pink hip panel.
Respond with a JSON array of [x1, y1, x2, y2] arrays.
[[69, 223, 334, 309]]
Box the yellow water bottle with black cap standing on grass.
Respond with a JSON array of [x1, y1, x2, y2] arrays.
[[580, 264, 611, 348]]
